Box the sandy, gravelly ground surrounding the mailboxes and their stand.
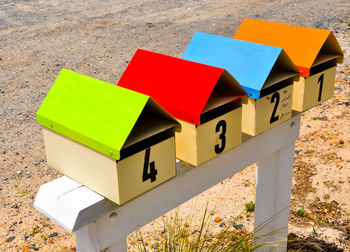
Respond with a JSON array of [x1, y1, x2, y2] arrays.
[[0, 0, 350, 251]]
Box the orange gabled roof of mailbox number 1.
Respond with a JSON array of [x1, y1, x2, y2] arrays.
[[234, 19, 344, 77]]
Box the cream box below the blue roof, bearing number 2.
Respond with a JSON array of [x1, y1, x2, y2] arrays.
[[242, 85, 293, 136]]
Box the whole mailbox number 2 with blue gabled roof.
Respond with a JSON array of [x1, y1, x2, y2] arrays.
[[182, 32, 299, 136]]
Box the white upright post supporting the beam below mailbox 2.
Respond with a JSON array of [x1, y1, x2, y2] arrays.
[[254, 143, 294, 251]]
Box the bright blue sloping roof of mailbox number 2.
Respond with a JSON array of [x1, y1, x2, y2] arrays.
[[182, 32, 282, 99]]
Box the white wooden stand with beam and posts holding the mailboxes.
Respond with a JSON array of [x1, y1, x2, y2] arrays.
[[34, 113, 300, 252]]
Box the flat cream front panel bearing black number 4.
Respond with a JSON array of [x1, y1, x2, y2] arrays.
[[117, 137, 176, 204]]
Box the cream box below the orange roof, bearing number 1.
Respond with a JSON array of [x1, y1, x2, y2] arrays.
[[293, 66, 336, 112]]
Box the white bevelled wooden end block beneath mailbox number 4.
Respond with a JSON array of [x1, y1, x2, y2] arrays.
[[34, 176, 116, 232]]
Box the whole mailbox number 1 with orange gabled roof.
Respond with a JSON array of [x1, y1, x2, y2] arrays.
[[234, 19, 344, 112]]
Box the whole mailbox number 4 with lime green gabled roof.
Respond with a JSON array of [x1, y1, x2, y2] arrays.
[[37, 69, 180, 204]]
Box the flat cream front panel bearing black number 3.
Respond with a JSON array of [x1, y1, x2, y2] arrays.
[[197, 107, 242, 165]]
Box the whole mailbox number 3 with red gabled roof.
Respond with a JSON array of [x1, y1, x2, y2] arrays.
[[118, 50, 246, 166]]
